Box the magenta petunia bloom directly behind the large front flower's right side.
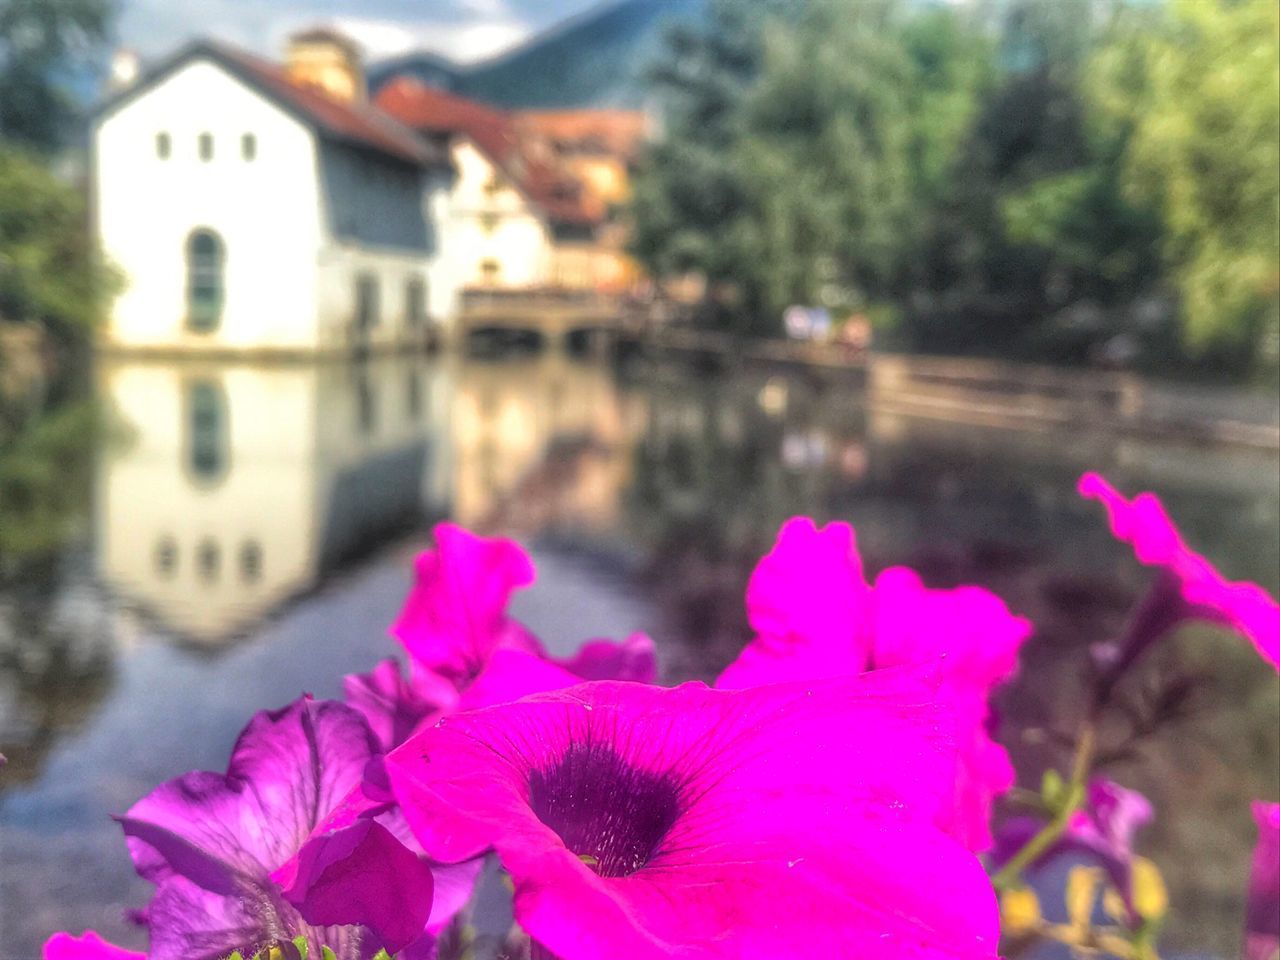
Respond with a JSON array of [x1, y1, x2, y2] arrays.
[[716, 517, 1032, 850]]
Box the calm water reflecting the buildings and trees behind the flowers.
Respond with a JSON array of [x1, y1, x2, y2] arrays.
[[0, 355, 1280, 957]]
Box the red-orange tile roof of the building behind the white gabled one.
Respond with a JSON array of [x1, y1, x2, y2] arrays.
[[375, 77, 604, 227]]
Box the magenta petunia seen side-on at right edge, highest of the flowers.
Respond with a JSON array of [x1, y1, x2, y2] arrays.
[[1079, 474, 1280, 669]]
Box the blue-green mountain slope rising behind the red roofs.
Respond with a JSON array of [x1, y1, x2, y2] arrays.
[[369, 0, 707, 110]]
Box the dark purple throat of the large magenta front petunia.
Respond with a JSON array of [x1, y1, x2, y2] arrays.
[[529, 744, 681, 877]]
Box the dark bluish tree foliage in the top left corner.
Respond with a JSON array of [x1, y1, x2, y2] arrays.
[[0, 0, 115, 150]]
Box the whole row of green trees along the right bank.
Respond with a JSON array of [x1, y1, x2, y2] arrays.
[[634, 0, 1280, 371]]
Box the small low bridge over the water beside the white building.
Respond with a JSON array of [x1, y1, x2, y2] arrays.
[[456, 287, 623, 343]]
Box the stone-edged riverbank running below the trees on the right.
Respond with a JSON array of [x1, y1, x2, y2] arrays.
[[621, 328, 1280, 451]]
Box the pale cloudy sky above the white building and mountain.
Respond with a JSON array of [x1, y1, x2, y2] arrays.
[[116, 0, 599, 63]]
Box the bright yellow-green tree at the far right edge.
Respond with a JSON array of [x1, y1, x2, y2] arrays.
[[1119, 0, 1280, 353]]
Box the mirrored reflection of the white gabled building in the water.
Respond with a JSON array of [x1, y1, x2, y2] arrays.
[[95, 360, 449, 645]]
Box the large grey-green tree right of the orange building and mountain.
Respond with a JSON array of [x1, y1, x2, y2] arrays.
[[632, 0, 991, 333]]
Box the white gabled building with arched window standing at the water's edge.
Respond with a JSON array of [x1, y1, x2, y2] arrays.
[[92, 31, 457, 353]]
